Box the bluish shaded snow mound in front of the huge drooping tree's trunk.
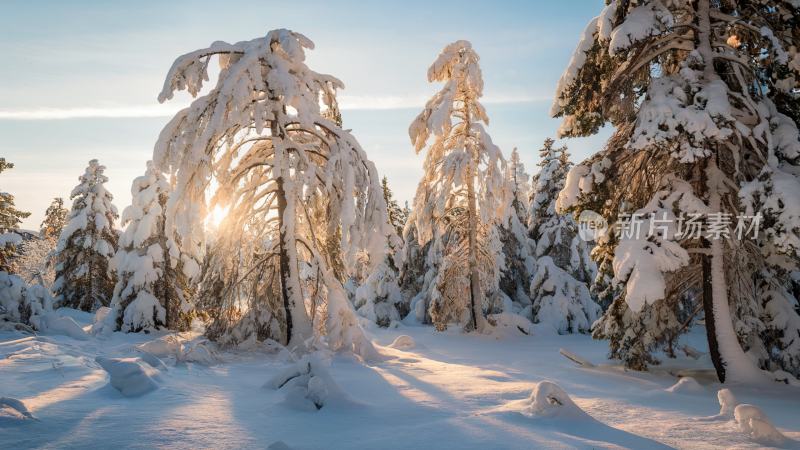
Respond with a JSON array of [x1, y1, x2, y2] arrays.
[[264, 353, 349, 411]]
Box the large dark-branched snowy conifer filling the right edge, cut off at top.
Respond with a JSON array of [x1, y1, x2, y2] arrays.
[[551, 0, 800, 382]]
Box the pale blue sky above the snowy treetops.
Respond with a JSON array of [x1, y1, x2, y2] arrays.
[[0, 0, 607, 228]]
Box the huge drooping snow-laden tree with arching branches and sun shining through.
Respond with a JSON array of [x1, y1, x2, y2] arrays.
[[155, 30, 392, 354]]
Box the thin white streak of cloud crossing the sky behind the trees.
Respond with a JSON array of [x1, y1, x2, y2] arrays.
[[0, 95, 549, 120]]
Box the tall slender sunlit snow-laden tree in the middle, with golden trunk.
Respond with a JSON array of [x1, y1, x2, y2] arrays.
[[407, 41, 508, 331]]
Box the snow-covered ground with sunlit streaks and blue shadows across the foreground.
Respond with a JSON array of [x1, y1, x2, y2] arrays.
[[0, 310, 800, 449]]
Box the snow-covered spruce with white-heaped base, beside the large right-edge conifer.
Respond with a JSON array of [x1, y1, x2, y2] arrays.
[[528, 138, 600, 333]]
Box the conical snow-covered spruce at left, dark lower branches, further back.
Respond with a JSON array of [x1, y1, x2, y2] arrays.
[[53, 159, 119, 312]]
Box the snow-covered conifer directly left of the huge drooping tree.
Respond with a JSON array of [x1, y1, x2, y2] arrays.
[[110, 161, 191, 332]]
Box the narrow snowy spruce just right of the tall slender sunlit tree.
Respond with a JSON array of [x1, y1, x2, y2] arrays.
[[500, 148, 535, 317]]
